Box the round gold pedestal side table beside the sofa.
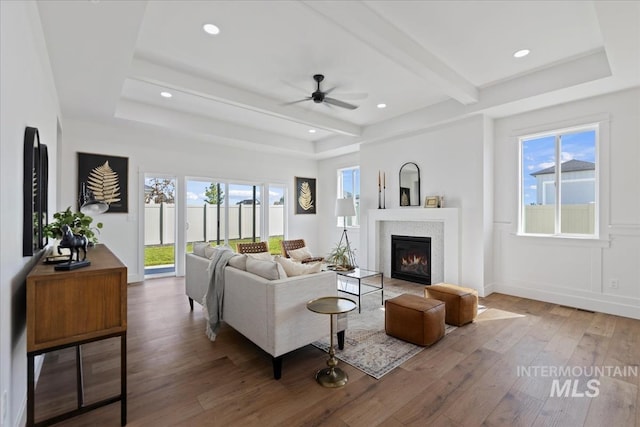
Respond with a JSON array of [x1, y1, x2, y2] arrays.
[[307, 297, 356, 388]]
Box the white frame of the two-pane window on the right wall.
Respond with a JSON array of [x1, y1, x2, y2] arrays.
[[518, 122, 601, 239]]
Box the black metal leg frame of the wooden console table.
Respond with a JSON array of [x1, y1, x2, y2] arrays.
[[27, 332, 127, 426]]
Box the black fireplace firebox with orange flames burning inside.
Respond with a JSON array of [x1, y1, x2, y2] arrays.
[[391, 235, 431, 285]]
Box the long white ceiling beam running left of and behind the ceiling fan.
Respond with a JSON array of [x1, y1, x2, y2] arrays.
[[129, 58, 362, 136]]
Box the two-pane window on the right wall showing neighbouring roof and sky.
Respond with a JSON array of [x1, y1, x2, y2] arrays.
[[519, 125, 598, 237]]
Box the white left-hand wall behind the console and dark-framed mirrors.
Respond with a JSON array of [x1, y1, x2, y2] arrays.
[[0, 1, 58, 426]]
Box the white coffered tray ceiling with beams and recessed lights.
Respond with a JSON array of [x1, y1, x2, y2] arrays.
[[38, 0, 640, 158]]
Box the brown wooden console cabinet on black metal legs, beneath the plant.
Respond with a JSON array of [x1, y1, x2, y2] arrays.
[[27, 245, 127, 426]]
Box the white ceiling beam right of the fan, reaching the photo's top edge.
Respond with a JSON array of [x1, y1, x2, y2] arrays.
[[303, 1, 479, 105]]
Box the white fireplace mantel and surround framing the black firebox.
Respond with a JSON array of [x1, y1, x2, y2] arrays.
[[367, 208, 460, 283]]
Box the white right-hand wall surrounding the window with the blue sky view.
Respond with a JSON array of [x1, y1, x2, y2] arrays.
[[493, 88, 640, 318]]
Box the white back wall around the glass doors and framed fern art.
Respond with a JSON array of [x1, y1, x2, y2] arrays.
[[58, 120, 322, 282]]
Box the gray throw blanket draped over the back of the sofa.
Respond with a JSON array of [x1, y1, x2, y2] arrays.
[[202, 246, 235, 341]]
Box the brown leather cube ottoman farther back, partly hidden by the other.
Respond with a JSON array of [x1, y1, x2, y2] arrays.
[[424, 283, 478, 326]]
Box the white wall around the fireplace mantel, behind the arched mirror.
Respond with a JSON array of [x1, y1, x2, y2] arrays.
[[332, 116, 491, 294]]
